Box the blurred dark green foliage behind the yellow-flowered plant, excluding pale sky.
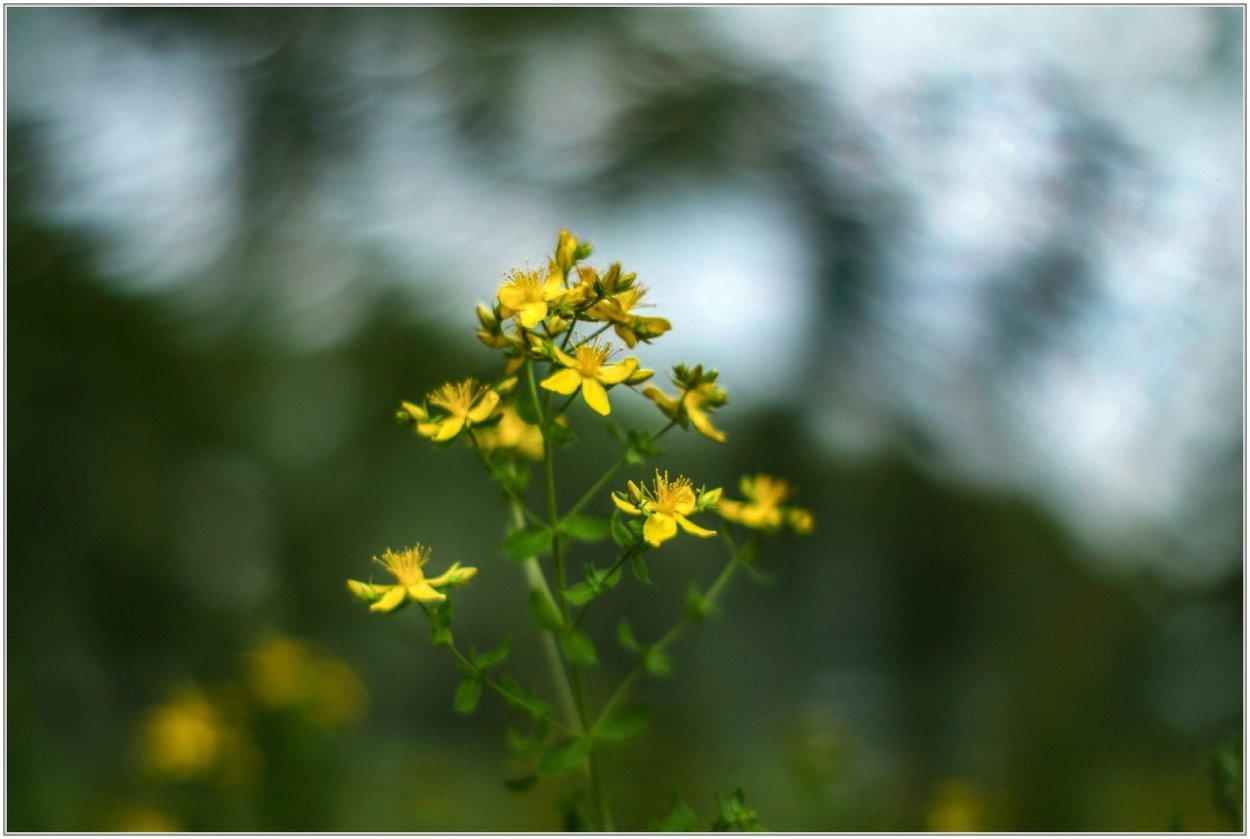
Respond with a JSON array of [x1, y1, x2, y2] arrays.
[[5, 8, 1243, 831]]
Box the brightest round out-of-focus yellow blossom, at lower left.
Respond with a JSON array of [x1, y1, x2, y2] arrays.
[[143, 688, 225, 780]]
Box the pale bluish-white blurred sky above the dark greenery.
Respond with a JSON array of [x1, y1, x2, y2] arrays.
[[6, 6, 1244, 581]]
